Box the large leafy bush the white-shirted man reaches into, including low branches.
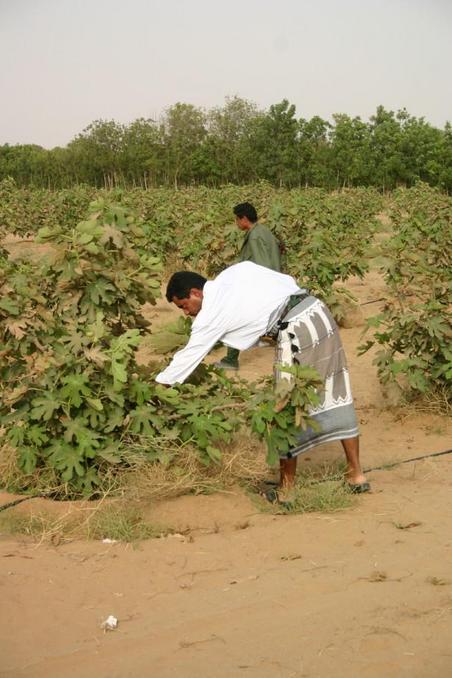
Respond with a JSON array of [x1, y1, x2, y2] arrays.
[[0, 201, 272, 496]]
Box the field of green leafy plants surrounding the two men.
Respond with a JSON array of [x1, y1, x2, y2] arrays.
[[0, 180, 452, 498]]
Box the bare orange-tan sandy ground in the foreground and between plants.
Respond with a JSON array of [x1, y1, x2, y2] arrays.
[[0, 274, 452, 678]]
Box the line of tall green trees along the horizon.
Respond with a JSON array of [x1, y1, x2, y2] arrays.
[[0, 97, 452, 191]]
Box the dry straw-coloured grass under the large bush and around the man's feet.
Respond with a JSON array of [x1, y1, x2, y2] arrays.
[[0, 434, 353, 545]]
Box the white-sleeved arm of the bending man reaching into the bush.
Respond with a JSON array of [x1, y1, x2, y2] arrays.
[[155, 324, 225, 385]]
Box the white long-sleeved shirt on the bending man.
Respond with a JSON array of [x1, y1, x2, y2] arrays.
[[156, 261, 300, 384]]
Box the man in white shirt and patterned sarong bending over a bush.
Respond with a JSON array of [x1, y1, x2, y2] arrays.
[[156, 262, 370, 500]]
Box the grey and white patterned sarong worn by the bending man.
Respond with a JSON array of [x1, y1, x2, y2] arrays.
[[275, 296, 359, 458]]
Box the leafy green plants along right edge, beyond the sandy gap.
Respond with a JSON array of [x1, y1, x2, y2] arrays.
[[361, 185, 452, 400]]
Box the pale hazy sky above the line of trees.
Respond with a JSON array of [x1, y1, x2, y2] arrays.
[[0, 0, 452, 148]]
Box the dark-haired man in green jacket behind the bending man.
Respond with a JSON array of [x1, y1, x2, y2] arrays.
[[215, 202, 281, 370]]
